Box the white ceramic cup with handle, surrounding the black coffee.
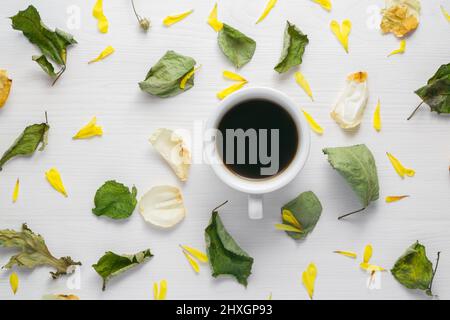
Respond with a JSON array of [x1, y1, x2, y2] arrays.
[[206, 87, 311, 219]]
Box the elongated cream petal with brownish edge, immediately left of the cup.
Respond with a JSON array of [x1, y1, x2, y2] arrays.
[[150, 128, 191, 181]]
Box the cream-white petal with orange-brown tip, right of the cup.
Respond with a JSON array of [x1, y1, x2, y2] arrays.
[[331, 72, 369, 129]]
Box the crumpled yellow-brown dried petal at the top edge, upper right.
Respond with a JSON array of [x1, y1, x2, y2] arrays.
[[381, 0, 421, 38]]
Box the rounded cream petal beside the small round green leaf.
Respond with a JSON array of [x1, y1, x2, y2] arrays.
[[139, 186, 186, 228]]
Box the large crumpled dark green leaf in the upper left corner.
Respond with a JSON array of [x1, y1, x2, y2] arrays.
[[11, 5, 77, 79]]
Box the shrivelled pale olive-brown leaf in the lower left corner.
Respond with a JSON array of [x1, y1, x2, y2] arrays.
[[0, 224, 81, 279]]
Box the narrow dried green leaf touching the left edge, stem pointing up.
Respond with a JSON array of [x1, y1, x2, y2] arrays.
[[0, 123, 50, 171]]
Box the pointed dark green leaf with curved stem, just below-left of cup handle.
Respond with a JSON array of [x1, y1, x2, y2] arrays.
[[205, 204, 253, 286]]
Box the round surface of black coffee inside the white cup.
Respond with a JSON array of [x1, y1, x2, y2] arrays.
[[215, 98, 300, 180]]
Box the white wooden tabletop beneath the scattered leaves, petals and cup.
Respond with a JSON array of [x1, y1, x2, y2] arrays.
[[0, 0, 450, 299]]
